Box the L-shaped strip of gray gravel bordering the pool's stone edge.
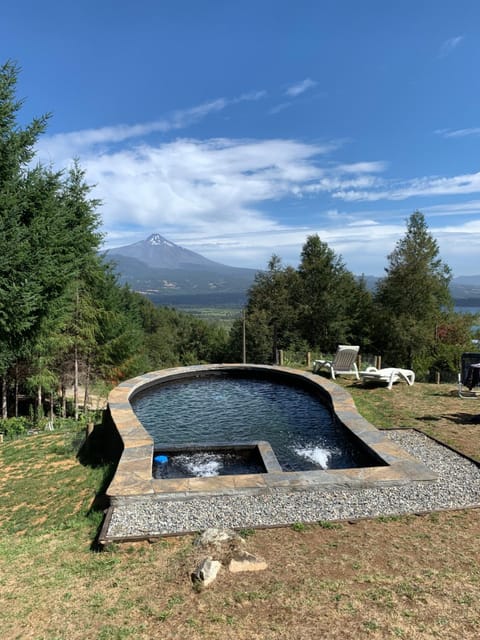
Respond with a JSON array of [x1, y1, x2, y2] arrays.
[[105, 430, 480, 539]]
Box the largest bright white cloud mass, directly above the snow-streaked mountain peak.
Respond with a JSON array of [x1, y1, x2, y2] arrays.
[[81, 139, 330, 238]]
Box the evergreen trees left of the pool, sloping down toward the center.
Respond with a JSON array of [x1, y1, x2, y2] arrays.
[[0, 62, 226, 419]]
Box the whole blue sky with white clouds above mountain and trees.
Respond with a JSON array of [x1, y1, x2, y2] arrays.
[[0, 0, 480, 275]]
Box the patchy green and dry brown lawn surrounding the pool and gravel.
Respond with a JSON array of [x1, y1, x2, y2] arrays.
[[0, 381, 480, 640]]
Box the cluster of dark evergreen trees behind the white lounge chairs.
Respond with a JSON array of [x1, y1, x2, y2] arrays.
[[231, 211, 473, 379]]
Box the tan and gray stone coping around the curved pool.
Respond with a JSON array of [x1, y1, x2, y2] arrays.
[[107, 364, 437, 506]]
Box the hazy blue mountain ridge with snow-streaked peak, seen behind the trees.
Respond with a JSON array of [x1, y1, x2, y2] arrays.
[[107, 233, 480, 307]]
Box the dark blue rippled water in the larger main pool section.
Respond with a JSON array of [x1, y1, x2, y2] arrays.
[[131, 374, 368, 471]]
